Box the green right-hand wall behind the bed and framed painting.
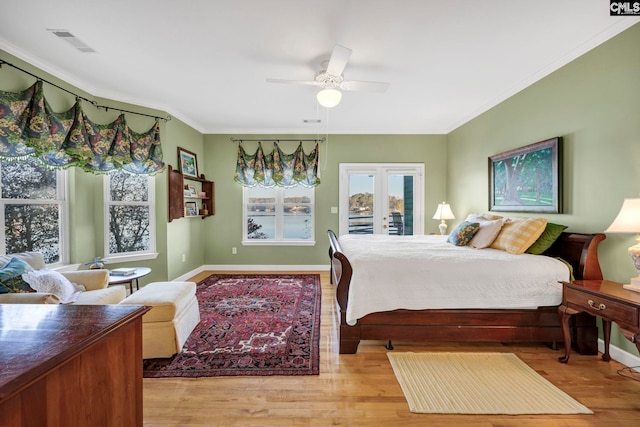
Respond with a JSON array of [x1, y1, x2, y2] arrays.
[[447, 24, 640, 354]]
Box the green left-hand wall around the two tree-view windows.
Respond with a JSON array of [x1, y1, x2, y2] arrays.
[[0, 50, 204, 284]]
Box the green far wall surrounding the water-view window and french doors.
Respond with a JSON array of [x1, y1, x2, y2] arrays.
[[202, 134, 446, 267]]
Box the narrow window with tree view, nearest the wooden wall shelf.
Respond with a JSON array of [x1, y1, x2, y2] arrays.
[[104, 171, 157, 261]]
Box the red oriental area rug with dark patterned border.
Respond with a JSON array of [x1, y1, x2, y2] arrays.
[[143, 274, 321, 378]]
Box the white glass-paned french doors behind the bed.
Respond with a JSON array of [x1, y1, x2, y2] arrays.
[[339, 163, 424, 236]]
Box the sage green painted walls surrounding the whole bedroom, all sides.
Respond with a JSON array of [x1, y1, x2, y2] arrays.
[[5, 24, 640, 354]]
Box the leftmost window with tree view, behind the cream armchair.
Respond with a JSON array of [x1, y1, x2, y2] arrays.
[[0, 158, 68, 264]]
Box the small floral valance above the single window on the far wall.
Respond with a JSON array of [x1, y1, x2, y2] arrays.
[[234, 142, 320, 187]]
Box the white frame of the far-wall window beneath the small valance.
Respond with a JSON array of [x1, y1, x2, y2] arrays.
[[241, 186, 316, 246]]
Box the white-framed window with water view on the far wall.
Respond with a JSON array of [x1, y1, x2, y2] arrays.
[[243, 185, 315, 245]]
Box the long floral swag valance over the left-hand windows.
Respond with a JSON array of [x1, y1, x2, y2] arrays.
[[0, 80, 164, 174]]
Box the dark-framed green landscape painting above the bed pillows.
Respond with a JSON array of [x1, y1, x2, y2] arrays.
[[489, 137, 562, 213]]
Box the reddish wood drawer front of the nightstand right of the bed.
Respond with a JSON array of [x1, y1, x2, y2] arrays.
[[564, 287, 638, 327]]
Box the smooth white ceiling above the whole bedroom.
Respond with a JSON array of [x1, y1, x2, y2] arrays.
[[0, 0, 640, 134]]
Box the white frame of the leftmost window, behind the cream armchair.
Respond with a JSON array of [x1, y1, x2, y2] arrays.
[[0, 159, 70, 269]]
